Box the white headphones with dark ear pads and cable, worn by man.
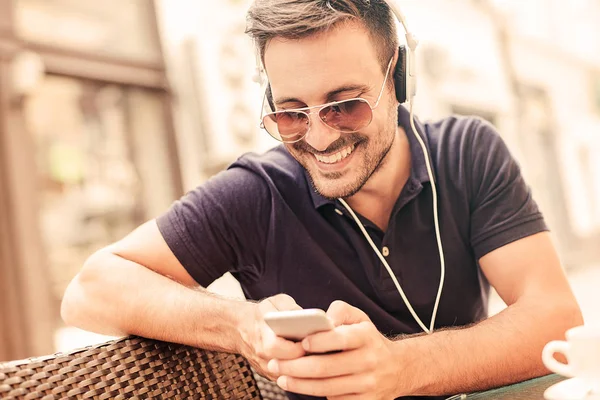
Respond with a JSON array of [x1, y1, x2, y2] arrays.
[[255, 0, 446, 334]]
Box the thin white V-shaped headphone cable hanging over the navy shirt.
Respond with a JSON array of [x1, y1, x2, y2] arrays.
[[338, 99, 446, 334]]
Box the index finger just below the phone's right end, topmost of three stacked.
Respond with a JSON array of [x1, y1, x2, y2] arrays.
[[302, 322, 372, 353]]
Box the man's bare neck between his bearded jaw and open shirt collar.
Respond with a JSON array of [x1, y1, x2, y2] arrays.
[[346, 127, 411, 232]]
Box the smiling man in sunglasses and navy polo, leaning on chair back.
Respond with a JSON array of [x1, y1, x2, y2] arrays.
[[62, 0, 582, 399]]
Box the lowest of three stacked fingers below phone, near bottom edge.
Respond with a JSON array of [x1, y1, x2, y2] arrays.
[[277, 374, 377, 397]]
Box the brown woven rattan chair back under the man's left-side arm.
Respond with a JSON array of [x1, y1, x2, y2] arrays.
[[0, 337, 262, 400]]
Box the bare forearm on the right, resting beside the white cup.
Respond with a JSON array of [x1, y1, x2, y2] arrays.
[[396, 299, 582, 395]]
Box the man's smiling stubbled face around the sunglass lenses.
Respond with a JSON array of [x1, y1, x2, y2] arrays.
[[265, 22, 397, 198]]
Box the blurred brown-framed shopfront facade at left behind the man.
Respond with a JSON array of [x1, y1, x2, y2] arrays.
[[0, 0, 183, 360]]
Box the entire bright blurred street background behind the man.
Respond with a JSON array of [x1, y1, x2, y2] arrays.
[[0, 0, 600, 360]]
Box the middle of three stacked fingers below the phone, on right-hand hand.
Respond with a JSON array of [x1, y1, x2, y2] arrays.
[[268, 350, 374, 379]]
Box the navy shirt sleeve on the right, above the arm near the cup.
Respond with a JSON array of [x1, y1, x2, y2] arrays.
[[470, 121, 548, 260]]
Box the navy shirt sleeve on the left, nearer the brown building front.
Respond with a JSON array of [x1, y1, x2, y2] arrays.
[[157, 167, 271, 287]]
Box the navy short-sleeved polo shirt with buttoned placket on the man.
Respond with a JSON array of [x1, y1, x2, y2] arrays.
[[157, 107, 547, 399]]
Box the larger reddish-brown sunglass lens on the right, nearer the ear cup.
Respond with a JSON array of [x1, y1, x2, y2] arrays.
[[319, 99, 373, 132]]
